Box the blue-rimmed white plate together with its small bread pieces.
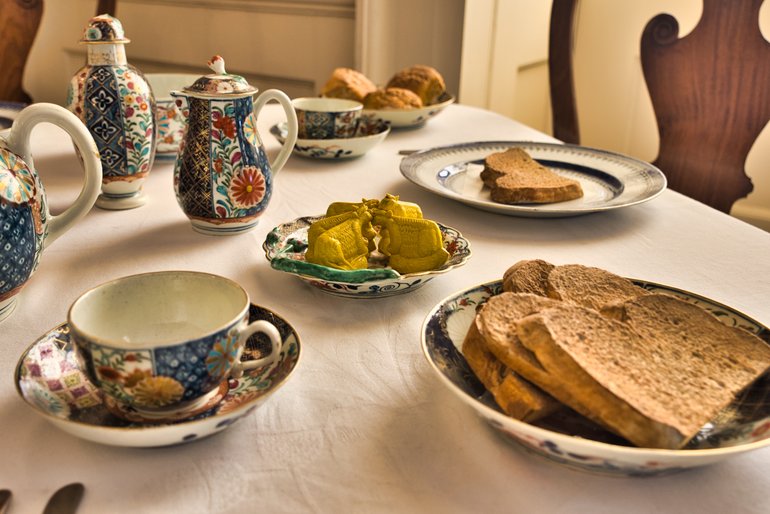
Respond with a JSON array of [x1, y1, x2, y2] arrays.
[[400, 141, 666, 218]]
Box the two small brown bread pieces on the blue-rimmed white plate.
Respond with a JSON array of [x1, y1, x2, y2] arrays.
[[481, 148, 583, 204]]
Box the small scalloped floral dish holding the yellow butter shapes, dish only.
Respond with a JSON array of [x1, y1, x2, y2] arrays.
[[262, 216, 471, 299]]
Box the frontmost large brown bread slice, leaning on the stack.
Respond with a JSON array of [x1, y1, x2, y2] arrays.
[[516, 295, 770, 448]]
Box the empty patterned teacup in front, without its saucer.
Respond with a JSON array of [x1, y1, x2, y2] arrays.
[[67, 271, 281, 421]]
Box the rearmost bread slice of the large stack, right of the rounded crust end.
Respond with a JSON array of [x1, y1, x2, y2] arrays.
[[546, 264, 649, 311]]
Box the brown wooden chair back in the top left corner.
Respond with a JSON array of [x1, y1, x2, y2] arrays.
[[0, 0, 43, 103]]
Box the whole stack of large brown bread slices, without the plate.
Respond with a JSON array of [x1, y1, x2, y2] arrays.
[[462, 260, 770, 449]]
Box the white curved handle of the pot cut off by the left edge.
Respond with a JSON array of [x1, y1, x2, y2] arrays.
[[7, 103, 102, 248]]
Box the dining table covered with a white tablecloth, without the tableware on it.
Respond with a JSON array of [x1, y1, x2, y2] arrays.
[[0, 103, 770, 514]]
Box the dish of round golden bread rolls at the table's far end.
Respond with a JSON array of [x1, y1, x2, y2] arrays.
[[321, 64, 455, 128]]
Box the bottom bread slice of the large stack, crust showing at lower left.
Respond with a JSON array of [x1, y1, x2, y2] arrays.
[[462, 320, 561, 422]]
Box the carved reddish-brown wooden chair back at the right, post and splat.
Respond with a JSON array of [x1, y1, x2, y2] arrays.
[[549, 0, 770, 212]]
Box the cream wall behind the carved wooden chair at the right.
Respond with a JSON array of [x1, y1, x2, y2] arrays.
[[460, 0, 770, 230]]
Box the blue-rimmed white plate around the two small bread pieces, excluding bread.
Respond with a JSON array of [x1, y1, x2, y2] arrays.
[[401, 141, 666, 218]]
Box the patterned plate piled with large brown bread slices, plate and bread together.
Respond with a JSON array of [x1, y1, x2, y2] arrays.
[[422, 259, 770, 476]]
